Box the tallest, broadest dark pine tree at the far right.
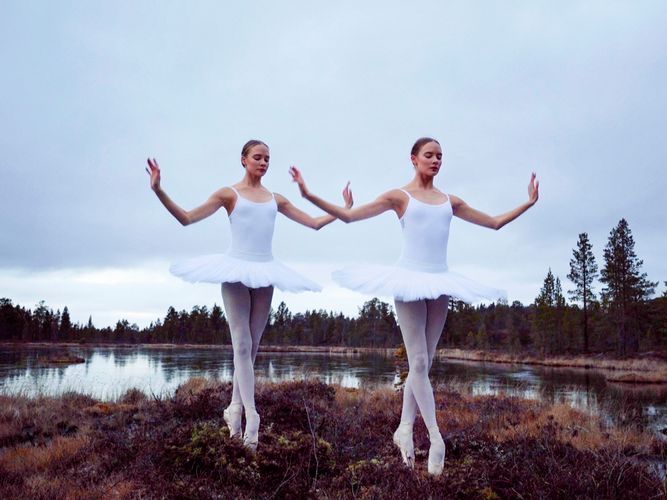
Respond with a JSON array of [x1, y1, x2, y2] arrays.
[[600, 219, 657, 355]]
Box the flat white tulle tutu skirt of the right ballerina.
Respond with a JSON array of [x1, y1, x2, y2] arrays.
[[332, 265, 507, 303]]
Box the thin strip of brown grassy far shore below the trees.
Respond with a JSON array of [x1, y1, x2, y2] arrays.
[[5, 341, 667, 384]]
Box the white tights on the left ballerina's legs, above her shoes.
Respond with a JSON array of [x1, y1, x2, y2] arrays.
[[222, 283, 273, 416]]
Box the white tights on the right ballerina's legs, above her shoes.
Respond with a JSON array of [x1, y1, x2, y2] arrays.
[[395, 295, 449, 429]]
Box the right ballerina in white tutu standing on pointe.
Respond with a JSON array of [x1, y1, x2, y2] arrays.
[[290, 137, 539, 475]]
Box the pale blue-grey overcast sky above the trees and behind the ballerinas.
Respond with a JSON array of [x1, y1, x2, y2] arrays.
[[0, 0, 667, 326]]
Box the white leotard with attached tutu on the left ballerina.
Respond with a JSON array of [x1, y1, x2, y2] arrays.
[[170, 187, 321, 292]]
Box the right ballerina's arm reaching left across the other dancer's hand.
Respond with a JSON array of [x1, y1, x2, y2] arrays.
[[290, 167, 400, 223]]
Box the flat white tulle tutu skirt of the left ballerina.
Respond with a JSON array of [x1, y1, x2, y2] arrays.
[[169, 254, 322, 292]]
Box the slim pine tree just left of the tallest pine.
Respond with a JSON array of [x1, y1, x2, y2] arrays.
[[567, 233, 598, 352]]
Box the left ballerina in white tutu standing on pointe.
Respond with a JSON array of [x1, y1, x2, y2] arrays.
[[146, 140, 347, 451]]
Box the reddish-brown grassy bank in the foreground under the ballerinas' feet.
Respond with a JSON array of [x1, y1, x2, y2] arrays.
[[0, 379, 667, 498]]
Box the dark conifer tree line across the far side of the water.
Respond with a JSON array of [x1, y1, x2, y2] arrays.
[[0, 219, 667, 355]]
